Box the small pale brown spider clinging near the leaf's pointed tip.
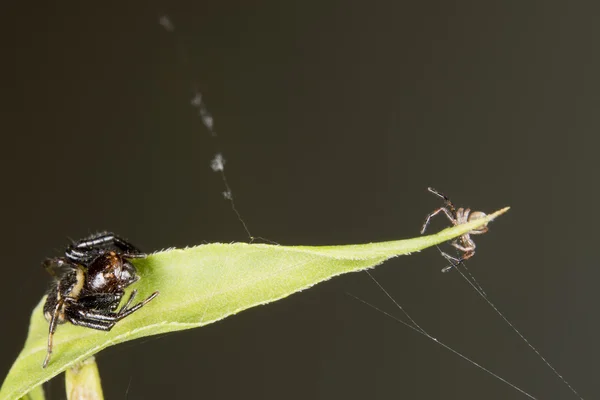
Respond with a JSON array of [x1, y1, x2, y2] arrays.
[[421, 188, 488, 272]]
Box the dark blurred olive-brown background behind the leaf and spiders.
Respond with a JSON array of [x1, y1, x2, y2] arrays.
[[0, 1, 600, 399]]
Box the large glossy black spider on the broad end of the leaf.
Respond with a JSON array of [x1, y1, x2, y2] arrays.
[[42, 232, 158, 368]]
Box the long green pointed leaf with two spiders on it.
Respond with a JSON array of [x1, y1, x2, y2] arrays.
[[0, 207, 508, 400]]
